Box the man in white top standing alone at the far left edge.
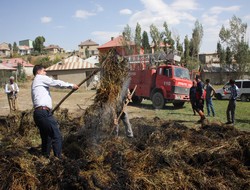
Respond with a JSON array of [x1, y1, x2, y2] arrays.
[[5, 76, 19, 111]]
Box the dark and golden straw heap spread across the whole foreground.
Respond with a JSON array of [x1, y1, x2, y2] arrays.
[[0, 111, 250, 189]]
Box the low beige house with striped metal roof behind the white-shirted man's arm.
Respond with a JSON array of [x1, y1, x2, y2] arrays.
[[46, 55, 97, 89]]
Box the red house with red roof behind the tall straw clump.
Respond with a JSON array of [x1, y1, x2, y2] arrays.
[[98, 35, 139, 56]]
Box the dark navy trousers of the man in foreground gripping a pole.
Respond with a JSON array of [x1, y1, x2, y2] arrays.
[[33, 110, 62, 157]]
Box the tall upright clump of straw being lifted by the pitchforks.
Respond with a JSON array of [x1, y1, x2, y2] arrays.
[[84, 49, 129, 140]]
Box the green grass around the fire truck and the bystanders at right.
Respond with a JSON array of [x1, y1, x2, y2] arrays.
[[134, 99, 250, 132]]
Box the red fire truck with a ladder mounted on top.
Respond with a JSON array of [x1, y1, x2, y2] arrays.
[[127, 52, 192, 109]]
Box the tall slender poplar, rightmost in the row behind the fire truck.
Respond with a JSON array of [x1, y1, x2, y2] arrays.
[[191, 20, 203, 58]]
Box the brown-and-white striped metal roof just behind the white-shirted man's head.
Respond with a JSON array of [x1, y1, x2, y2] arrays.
[[46, 55, 96, 71]]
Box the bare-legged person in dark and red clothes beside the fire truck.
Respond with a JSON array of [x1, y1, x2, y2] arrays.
[[195, 75, 206, 122]]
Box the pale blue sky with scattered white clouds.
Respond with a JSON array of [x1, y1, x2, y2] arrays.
[[0, 0, 250, 53]]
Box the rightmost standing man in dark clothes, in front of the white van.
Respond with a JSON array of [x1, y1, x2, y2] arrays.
[[226, 79, 239, 125]]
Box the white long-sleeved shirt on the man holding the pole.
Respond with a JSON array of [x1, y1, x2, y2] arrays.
[[31, 74, 73, 109]]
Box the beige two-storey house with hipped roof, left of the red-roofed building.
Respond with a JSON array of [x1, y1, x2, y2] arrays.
[[78, 39, 99, 59]]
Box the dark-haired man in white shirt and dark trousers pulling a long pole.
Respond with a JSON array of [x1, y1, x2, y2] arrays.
[[31, 65, 78, 158]]
